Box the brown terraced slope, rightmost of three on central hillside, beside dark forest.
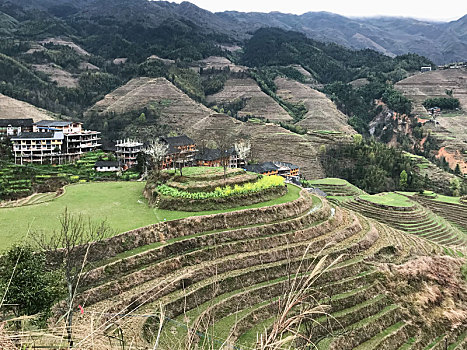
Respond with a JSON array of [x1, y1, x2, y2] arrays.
[[274, 78, 355, 134]]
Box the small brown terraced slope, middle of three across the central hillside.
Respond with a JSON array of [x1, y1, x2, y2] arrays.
[[206, 78, 292, 121]]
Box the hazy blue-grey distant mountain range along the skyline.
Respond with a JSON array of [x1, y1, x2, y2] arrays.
[[6, 0, 467, 64]]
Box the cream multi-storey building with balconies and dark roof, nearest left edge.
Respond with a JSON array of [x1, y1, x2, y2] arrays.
[[11, 131, 65, 164]]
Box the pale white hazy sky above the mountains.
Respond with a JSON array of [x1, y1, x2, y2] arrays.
[[169, 0, 467, 21]]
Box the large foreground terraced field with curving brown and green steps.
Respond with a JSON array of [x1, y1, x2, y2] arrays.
[[54, 191, 466, 350]]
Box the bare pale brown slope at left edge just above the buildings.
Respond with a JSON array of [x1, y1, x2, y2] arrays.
[[0, 94, 53, 121]]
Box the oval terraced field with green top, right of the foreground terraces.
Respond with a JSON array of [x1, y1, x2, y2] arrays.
[[341, 194, 467, 248]]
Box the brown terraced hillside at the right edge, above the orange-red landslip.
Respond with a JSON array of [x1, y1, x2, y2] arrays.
[[396, 69, 467, 114]]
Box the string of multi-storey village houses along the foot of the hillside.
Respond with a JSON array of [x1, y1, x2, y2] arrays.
[[0, 119, 300, 178]]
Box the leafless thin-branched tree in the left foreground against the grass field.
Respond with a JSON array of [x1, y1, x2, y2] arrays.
[[33, 208, 110, 347]]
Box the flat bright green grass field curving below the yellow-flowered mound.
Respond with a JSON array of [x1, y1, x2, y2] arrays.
[[0, 182, 300, 251]]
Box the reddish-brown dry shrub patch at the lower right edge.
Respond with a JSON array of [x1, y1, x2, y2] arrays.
[[380, 256, 467, 329]]
